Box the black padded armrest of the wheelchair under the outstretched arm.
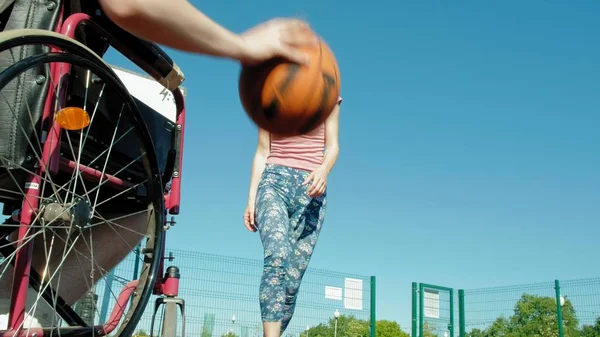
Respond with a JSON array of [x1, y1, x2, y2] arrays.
[[84, 16, 185, 91]]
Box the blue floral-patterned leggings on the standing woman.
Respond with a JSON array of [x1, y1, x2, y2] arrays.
[[255, 164, 326, 333]]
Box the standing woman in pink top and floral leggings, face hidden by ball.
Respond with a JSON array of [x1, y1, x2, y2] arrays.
[[244, 98, 342, 337]]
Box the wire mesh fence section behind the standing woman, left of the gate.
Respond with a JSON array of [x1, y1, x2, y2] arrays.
[[77, 249, 377, 337]]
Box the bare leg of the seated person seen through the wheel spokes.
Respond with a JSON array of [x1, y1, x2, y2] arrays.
[[0, 213, 149, 321]]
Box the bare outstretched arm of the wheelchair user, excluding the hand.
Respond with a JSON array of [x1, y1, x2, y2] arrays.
[[99, 0, 247, 60]]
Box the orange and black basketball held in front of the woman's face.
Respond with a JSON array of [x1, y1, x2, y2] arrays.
[[239, 33, 340, 136]]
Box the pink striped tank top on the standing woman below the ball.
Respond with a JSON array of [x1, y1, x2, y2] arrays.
[[267, 97, 342, 172]]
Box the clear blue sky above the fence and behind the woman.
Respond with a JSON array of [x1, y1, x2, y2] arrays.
[[104, 0, 600, 324]]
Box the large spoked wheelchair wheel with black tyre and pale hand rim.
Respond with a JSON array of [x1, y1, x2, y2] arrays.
[[0, 30, 165, 336]]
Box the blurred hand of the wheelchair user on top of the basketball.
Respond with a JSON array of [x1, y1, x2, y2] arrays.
[[240, 18, 318, 65]]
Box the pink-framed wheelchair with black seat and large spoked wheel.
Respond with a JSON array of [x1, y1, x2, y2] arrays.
[[0, 0, 185, 337]]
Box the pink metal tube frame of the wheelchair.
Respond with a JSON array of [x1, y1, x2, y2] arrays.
[[2, 5, 185, 337]]
